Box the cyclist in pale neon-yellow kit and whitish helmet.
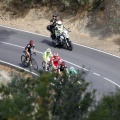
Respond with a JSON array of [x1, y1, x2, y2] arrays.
[[43, 48, 53, 70]]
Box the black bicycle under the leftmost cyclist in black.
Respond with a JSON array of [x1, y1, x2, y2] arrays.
[[21, 51, 38, 70]]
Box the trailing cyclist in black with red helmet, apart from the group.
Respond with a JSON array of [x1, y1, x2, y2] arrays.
[[25, 40, 36, 63]]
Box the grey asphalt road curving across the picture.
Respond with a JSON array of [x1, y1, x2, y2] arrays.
[[0, 26, 120, 98]]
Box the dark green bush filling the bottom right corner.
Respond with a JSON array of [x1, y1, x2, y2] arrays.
[[86, 89, 120, 120]]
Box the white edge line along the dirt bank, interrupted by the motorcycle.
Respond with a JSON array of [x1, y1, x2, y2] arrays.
[[0, 25, 120, 58]]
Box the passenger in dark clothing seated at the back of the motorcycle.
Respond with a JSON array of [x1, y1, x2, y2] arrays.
[[47, 14, 57, 39]]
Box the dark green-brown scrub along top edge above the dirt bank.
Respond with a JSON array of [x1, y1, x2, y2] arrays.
[[2, 0, 105, 14]]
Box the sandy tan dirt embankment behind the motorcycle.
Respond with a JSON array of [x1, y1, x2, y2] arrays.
[[0, 0, 120, 56]]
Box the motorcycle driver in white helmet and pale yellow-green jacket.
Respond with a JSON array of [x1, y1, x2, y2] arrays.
[[55, 21, 64, 44]]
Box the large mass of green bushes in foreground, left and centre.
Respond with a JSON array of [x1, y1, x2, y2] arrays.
[[0, 71, 94, 120]]
